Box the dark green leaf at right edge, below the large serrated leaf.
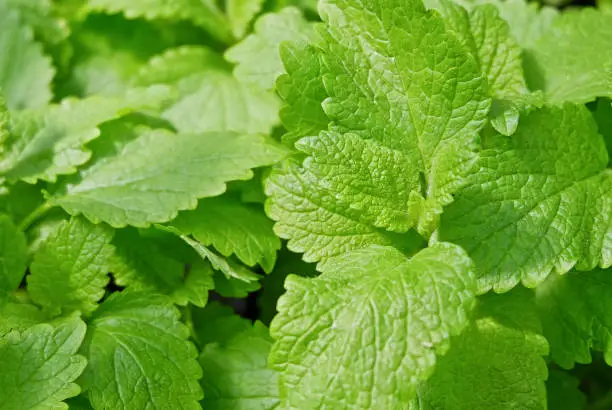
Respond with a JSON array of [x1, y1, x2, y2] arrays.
[[536, 269, 612, 369]]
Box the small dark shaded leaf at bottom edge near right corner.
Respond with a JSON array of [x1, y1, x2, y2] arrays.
[[546, 370, 587, 410]]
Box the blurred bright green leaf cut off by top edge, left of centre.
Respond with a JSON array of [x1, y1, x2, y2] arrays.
[[87, 0, 231, 42]]
